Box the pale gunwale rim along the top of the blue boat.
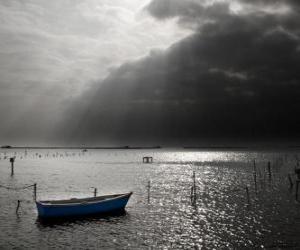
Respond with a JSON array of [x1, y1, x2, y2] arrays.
[[36, 192, 132, 207]]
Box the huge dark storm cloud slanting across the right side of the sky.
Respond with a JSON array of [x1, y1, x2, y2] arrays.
[[60, 0, 300, 144]]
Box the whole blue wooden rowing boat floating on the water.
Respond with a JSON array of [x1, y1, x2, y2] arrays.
[[36, 192, 132, 219]]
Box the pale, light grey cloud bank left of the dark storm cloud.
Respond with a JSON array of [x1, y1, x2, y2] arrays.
[[0, 0, 189, 144]]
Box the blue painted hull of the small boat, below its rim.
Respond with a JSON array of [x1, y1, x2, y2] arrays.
[[36, 193, 132, 218]]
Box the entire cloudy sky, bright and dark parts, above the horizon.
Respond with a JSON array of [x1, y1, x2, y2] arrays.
[[0, 0, 300, 146]]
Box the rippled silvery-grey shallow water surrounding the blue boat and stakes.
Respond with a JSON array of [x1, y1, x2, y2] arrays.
[[0, 149, 300, 249]]
